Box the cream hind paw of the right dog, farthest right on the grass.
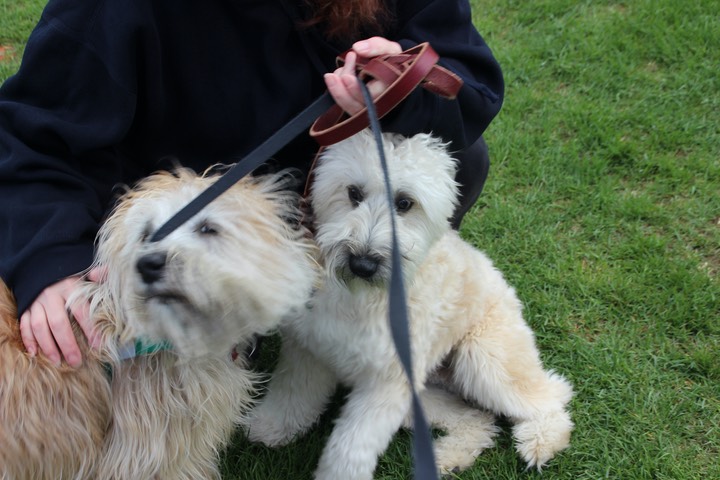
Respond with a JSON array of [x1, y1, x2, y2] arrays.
[[513, 410, 573, 470]]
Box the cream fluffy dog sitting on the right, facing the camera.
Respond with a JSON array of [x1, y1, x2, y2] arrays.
[[249, 132, 573, 480]]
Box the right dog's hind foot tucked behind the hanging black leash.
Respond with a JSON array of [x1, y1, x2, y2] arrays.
[[403, 386, 498, 474]]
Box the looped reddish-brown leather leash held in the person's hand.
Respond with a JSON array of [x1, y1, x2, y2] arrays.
[[310, 42, 463, 147]]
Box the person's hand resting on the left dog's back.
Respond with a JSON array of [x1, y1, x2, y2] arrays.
[[20, 269, 103, 367]]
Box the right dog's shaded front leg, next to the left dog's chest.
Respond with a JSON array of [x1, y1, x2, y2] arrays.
[[248, 336, 337, 446]]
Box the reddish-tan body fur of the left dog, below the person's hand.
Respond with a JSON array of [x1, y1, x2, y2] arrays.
[[0, 281, 110, 480]]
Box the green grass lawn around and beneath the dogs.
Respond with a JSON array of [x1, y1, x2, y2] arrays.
[[0, 0, 720, 479]]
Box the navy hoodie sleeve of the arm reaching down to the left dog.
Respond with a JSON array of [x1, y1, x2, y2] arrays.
[[0, 0, 140, 312]]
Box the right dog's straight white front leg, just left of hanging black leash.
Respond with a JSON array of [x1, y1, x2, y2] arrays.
[[315, 376, 410, 480]]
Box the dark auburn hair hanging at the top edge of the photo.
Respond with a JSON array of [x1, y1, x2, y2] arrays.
[[305, 0, 391, 40]]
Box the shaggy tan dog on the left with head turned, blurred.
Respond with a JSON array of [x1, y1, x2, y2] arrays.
[[0, 169, 316, 480]]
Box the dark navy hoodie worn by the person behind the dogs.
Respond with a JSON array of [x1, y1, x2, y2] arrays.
[[0, 0, 503, 312]]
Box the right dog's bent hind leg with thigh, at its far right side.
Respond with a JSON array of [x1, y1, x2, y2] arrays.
[[452, 290, 573, 468]]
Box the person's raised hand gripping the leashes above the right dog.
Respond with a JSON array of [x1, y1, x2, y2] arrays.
[[325, 37, 402, 115]]
